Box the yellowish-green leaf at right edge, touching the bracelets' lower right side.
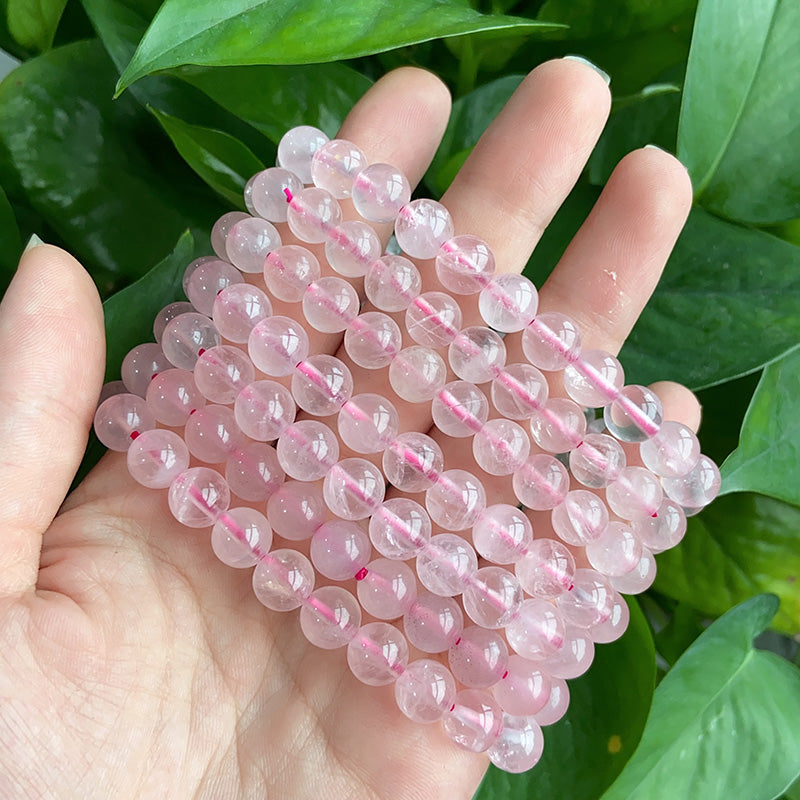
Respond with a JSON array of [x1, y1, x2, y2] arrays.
[[655, 493, 800, 635]]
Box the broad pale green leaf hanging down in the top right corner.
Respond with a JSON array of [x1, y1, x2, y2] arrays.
[[678, 0, 800, 223]]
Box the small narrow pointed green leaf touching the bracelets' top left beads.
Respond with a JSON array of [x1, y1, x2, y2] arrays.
[[149, 106, 264, 210]]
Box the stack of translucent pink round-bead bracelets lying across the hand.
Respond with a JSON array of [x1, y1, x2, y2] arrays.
[[94, 126, 720, 772]]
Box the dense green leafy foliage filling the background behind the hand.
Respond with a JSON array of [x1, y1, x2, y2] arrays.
[[0, 0, 800, 800]]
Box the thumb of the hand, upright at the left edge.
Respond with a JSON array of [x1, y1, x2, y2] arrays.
[[0, 245, 105, 595]]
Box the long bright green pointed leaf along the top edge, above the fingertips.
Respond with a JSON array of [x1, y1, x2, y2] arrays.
[[118, 0, 553, 91]]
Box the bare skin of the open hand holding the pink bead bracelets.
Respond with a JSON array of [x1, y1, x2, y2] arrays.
[[0, 60, 700, 800]]
